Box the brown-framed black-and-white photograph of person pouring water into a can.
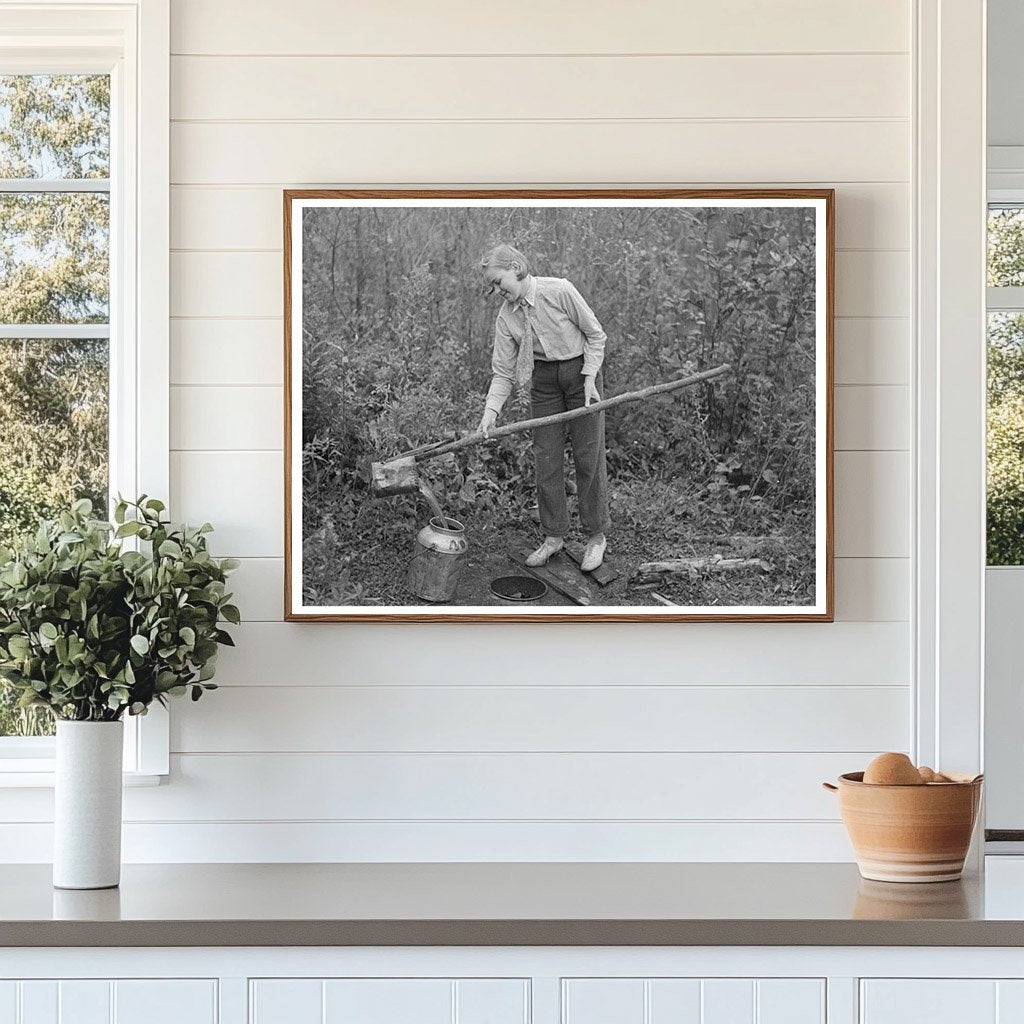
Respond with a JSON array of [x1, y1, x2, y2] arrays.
[[284, 189, 835, 622]]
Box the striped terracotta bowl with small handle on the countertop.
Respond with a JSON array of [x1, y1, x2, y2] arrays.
[[822, 771, 982, 882]]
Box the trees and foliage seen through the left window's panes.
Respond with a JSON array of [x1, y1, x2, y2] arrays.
[[0, 75, 111, 736]]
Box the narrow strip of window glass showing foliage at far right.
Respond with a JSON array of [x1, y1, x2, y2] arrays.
[[986, 197, 1024, 565]]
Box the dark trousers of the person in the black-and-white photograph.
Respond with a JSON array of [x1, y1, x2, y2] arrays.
[[530, 355, 611, 537]]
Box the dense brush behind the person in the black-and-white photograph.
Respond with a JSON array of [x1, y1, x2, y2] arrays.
[[301, 205, 815, 606]]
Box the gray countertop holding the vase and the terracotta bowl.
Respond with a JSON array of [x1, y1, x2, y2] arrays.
[[6, 858, 1024, 946]]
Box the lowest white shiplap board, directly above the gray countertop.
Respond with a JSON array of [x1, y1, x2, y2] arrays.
[[0, 812, 851, 864]]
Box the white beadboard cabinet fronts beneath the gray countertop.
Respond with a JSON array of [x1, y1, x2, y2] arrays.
[[6, 946, 1024, 1024]]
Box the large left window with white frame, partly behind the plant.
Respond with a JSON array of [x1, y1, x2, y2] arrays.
[[0, 0, 169, 785]]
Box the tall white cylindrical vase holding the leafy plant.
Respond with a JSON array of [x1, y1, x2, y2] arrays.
[[53, 720, 124, 889]]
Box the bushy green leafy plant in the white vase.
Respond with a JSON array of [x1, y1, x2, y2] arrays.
[[0, 495, 240, 722]]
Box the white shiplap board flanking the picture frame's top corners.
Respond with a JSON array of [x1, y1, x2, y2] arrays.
[[171, 181, 910, 252]]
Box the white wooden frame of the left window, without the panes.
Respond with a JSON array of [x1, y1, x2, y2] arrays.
[[0, 0, 170, 787]]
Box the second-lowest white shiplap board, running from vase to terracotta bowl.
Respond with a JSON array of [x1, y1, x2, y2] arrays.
[[110, 753, 864, 821]]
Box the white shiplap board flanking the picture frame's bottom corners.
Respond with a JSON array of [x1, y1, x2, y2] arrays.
[[230, 558, 910, 623]]
